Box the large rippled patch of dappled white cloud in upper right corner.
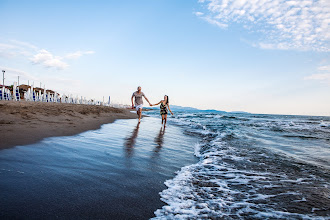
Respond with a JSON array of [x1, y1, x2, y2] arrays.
[[195, 0, 330, 52]]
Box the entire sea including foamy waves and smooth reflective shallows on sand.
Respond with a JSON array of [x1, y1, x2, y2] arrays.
[[0, 109, 330, 220]]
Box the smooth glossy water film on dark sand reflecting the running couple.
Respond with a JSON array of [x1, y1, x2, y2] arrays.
[[0, 118, 198, 219]]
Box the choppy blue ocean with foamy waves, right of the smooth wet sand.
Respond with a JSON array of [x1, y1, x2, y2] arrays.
[[148, 111, 330, 219]]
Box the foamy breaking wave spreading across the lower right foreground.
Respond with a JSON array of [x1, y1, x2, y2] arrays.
[[155, 132, 330, 219]]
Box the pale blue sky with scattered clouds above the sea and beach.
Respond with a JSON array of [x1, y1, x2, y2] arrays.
[[0, 0, 330, 116]]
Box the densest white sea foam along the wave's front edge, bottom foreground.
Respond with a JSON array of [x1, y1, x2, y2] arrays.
[[154, 158, 318, 219]]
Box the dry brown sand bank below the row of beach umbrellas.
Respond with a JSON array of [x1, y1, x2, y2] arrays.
[[0, 101, 136, 149]]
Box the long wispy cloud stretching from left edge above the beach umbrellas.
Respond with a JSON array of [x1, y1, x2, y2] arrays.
[[0, 40, 95, 70]]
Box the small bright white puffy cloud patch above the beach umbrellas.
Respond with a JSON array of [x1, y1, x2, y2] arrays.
[[31, 49, 69, 70]]
